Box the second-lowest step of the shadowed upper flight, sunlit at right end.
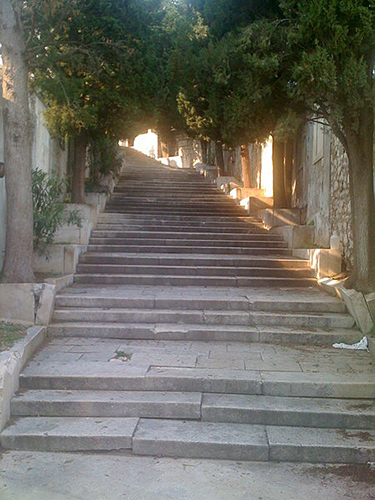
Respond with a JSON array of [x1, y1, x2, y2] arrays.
[[77, 263, 314, 278]]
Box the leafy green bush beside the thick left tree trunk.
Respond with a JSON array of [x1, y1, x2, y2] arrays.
[[32, 169, 82, 253]]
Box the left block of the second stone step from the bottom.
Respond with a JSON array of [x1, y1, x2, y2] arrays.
[[11, 390, 202, 420]]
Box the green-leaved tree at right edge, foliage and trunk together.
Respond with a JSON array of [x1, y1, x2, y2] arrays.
[[281, 0, 375, 292]]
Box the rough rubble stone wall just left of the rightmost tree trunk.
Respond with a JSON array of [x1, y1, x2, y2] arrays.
[[330, 134, 353, 268]]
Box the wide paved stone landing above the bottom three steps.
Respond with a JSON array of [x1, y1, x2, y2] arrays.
[[28, 337, 375, 379]]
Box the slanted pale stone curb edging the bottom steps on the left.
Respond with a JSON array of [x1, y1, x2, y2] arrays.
[[0, 326, 47, 431]]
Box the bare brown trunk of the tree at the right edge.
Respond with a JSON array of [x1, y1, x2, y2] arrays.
[[346, 117, 375, 293]]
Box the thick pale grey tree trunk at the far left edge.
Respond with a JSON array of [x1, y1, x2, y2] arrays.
[[0, 0, 34, 283]]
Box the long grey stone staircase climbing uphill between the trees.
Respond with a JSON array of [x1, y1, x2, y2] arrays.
[[1, 153, 375, 463]]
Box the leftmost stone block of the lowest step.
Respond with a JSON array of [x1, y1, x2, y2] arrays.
[[0, 417, 138, 451]]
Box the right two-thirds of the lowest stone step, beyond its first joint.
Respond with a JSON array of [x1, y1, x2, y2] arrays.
[[133, 419, 375, 463]]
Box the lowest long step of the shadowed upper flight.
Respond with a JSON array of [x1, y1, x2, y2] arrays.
[[74, 274, 316, 287]]
